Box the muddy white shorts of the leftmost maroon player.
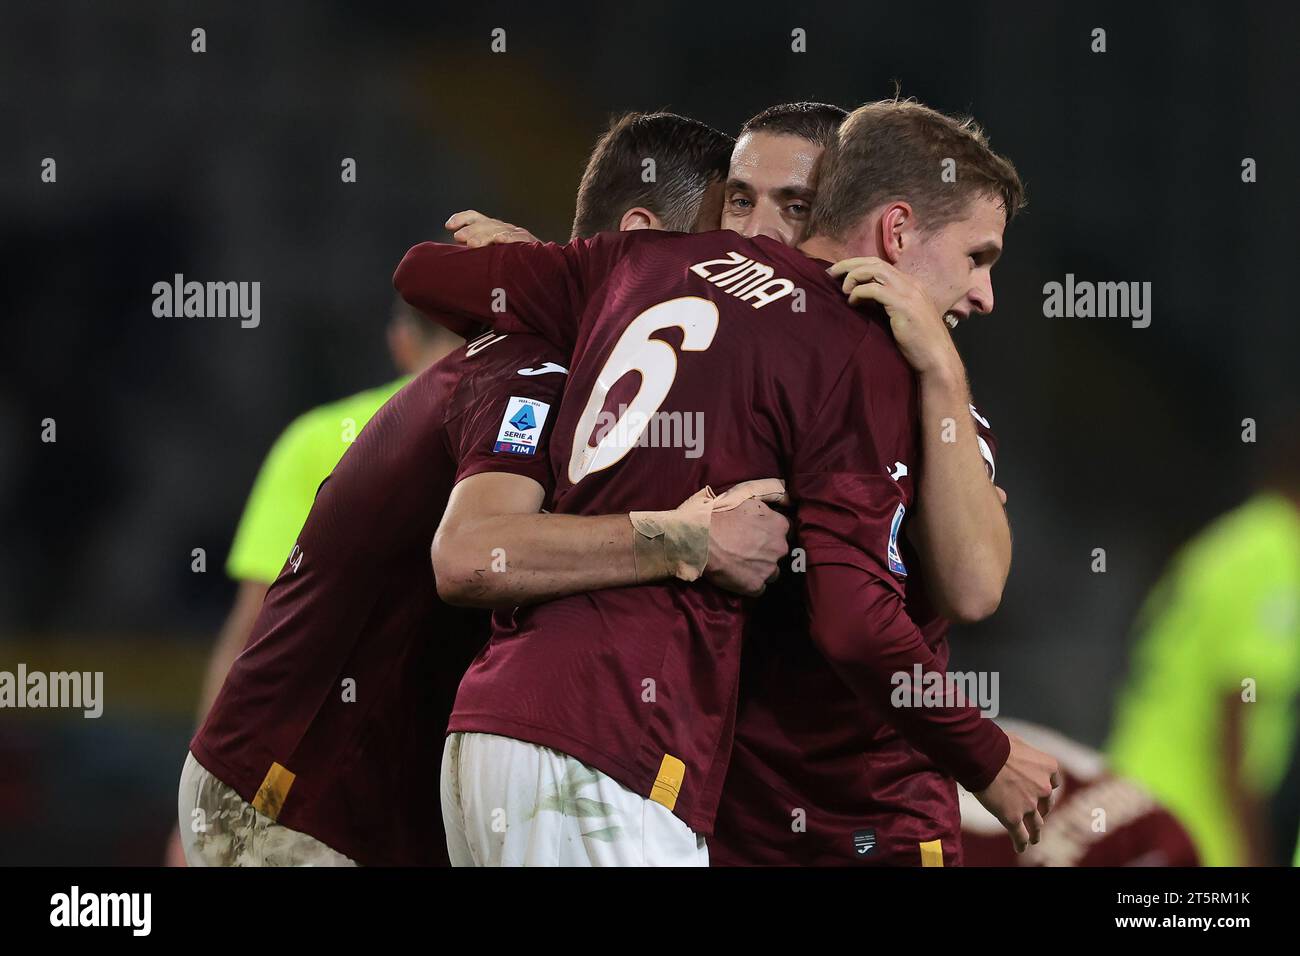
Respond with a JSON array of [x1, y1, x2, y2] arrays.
[[177, 753, 356, 866]]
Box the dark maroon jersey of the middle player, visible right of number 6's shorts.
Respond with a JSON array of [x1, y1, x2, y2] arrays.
[[709, 408, 997, 866]]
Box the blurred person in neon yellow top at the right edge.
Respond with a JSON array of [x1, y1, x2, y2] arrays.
[[1108, 418, 1300, 866]]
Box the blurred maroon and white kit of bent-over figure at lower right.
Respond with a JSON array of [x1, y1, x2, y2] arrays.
[[961, 719, 1200, 866]]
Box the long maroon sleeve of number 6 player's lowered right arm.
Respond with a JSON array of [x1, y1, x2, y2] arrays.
[[790, 334, 1010, 792]]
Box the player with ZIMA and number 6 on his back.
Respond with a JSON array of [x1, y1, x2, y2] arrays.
[[395, 103, 1054, 862]]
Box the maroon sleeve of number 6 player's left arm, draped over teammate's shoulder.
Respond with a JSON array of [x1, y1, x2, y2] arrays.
[[393, 230, 645, 355]]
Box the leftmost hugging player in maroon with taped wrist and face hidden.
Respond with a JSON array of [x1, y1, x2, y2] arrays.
[[178, 114, 785, 865]]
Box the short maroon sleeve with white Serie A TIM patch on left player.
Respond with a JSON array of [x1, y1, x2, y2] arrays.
[[447, 350, 568, 498]]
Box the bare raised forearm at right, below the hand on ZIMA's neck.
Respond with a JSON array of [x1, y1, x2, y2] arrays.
[[913, 355, 1011, 623]]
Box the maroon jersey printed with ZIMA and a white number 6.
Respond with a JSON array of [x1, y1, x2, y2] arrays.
[[394, 232, 1008, 834]]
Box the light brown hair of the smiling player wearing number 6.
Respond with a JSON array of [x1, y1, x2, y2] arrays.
[[809, 98, 1024, 239]]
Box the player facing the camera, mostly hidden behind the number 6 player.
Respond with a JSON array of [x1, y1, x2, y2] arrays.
[[434, 103, 1010, 865]]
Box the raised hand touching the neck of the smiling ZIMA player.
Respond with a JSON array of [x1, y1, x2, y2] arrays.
[[827, 256, 962, 375]]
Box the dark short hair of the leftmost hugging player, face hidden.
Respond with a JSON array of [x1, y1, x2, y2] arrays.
[[573, 113, 736, 238]]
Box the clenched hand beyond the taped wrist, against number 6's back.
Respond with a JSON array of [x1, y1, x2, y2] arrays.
[[705, 498, 790, 597]]
